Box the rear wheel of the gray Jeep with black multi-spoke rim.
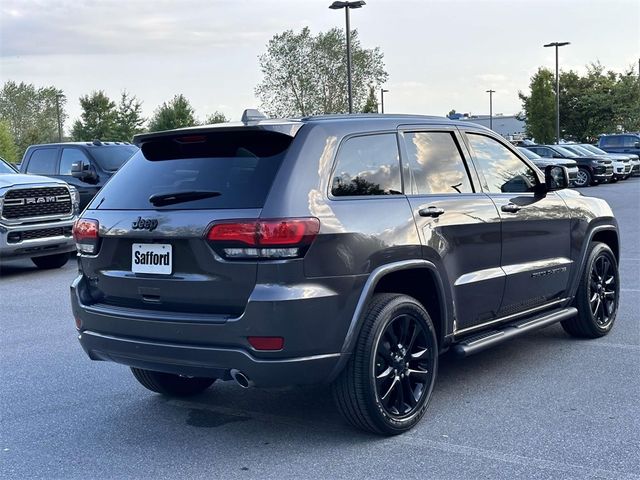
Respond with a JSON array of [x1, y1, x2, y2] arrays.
[[333, 293, 438, 435]]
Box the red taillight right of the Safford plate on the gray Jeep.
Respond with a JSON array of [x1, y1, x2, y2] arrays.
[[207, 217, 320, 259]]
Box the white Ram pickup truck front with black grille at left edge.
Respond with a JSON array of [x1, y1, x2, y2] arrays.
[[0, 159, 79, 275]]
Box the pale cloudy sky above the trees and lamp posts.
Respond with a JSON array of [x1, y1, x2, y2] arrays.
[[0, 0, 640, 130]]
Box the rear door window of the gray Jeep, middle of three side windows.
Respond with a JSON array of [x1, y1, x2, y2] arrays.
[[404, 132, 473, 194]]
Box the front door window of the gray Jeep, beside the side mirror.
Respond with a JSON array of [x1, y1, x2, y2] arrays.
[[468, 133, 538, 193]]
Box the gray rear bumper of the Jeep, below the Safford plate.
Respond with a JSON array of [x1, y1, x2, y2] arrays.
[[71, 276, 364, 387]]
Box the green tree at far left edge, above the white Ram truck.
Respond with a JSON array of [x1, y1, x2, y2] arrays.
[[0, 81, 67, 156]]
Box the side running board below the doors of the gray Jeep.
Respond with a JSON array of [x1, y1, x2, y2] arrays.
[[452, 307, 578, 357]]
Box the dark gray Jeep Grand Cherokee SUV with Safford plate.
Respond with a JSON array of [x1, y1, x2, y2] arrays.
[[71, 115, 620, 435]]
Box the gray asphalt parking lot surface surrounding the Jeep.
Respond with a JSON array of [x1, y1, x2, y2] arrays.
[[0, 177, 640, 479]]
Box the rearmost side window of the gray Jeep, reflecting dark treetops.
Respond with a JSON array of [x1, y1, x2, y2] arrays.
[[331, 133, 402, 197]]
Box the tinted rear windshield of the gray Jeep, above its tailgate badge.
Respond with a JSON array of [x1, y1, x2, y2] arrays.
[[89, 130, 293, 210]]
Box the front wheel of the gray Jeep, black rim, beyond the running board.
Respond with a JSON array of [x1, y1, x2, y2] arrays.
[[562, 242, 620, 338]]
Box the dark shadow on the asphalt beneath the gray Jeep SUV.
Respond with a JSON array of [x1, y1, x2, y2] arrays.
[[105, 329, 571, 443]]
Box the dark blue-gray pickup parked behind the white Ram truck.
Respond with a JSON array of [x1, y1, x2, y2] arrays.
[[20, 140, 138, 209]]
